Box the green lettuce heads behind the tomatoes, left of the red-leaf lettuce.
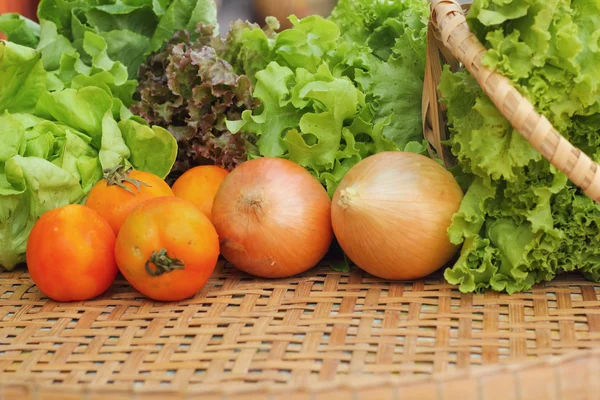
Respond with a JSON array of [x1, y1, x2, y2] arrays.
[[0, 0, 221, 269]]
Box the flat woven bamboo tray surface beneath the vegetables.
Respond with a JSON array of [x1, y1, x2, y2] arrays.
[[0, 264, 600, 399]]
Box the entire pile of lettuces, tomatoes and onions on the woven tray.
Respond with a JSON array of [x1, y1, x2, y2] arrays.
[[9, 0, 600, 300]]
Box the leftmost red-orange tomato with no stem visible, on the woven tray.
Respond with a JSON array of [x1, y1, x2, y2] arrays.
[[25, 204, 118, 302]]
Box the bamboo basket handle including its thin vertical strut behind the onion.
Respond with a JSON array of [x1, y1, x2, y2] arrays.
[[423, 0, 600, 202]]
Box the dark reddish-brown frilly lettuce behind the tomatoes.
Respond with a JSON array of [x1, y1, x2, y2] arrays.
[[132, 24, 256, 182]]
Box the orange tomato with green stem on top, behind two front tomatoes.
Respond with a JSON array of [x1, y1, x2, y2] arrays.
[[85, 166, 173, 235]]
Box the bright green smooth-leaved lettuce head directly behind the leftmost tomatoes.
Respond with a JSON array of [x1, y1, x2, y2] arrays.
[[0, 37, 177, 269]]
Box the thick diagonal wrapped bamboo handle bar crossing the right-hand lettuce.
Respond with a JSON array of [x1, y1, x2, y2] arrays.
[[431, 0, 600, 203]]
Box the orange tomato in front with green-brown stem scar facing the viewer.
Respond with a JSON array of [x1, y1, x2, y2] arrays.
[[115, 197, 219, 301]]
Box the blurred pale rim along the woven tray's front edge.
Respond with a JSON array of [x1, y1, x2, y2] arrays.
[[0, 347, 600, 399]]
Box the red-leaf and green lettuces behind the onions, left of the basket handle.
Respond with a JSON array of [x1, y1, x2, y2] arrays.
[[132, 0, 429, 196]]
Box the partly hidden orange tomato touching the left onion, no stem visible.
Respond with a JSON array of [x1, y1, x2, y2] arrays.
[[172, 165, 229, 219]]
